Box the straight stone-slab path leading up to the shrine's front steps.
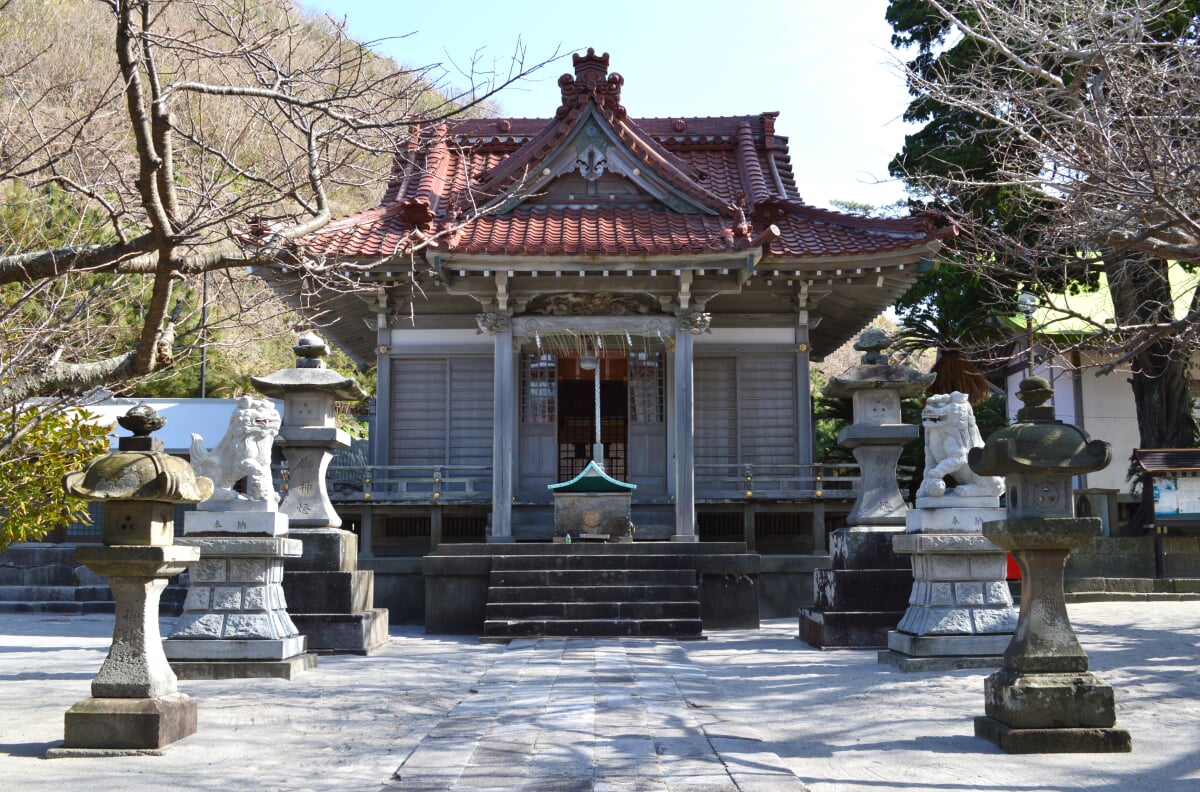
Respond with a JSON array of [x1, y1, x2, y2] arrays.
[[385, 638, 805, 792]]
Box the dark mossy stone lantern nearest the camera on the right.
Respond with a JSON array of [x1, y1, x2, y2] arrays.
[[970, 377, 1132, 754]]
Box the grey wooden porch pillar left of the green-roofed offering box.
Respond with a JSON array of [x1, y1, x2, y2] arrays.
[[479, 313, 516, 542]]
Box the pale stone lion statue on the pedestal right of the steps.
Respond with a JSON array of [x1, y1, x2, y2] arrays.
[[917, 391, 1004, 498]]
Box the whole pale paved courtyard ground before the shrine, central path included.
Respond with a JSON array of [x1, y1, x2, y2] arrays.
[[0, 602, 1200, 792]]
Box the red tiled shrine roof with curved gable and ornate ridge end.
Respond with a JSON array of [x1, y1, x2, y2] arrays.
[[295, 49, 950, 259]]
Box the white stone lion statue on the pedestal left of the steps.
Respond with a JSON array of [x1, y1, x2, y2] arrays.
[[192, 396, 280, 511]]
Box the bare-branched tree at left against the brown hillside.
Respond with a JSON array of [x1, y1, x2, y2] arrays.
[[0, 0, 552, 424]]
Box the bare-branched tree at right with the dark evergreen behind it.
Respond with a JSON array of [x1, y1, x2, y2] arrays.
[[908, 0, 1200, 446]]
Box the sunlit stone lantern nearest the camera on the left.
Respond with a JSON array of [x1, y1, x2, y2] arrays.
[[47, 404, 212, 756]]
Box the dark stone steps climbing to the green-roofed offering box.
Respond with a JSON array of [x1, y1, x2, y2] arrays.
[[484, 545, 703, 641]]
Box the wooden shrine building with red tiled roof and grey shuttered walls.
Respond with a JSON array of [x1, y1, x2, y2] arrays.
[[280, 49, 949, 558]]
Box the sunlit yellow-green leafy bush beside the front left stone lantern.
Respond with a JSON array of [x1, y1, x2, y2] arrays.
[[0, 407, 108, 551]]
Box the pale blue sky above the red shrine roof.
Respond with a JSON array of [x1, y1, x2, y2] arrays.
[[302, 0, 912, 205]]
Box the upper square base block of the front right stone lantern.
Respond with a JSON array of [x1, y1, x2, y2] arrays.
[[983, 668, 1116, 730]]
